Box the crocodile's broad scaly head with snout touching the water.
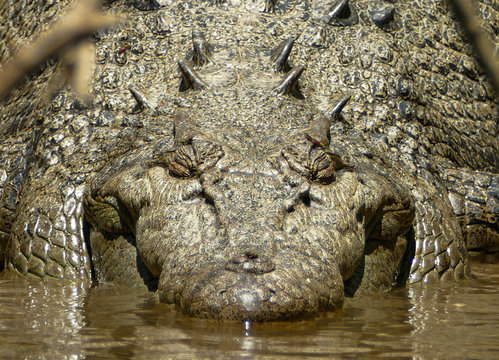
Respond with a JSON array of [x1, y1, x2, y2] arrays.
[[85, 64, 414, 321]]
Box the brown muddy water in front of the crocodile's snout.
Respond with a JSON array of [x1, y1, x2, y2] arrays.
[[0, 258, 499, 359]]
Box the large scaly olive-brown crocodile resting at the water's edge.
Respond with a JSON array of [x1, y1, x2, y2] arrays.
[[0, 0, 499, 321]]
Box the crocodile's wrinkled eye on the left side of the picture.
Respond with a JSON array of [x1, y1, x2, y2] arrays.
[[160, 137, 224, 178]]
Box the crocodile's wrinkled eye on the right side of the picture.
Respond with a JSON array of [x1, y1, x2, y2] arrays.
[[282, 134, 345, 184]]
